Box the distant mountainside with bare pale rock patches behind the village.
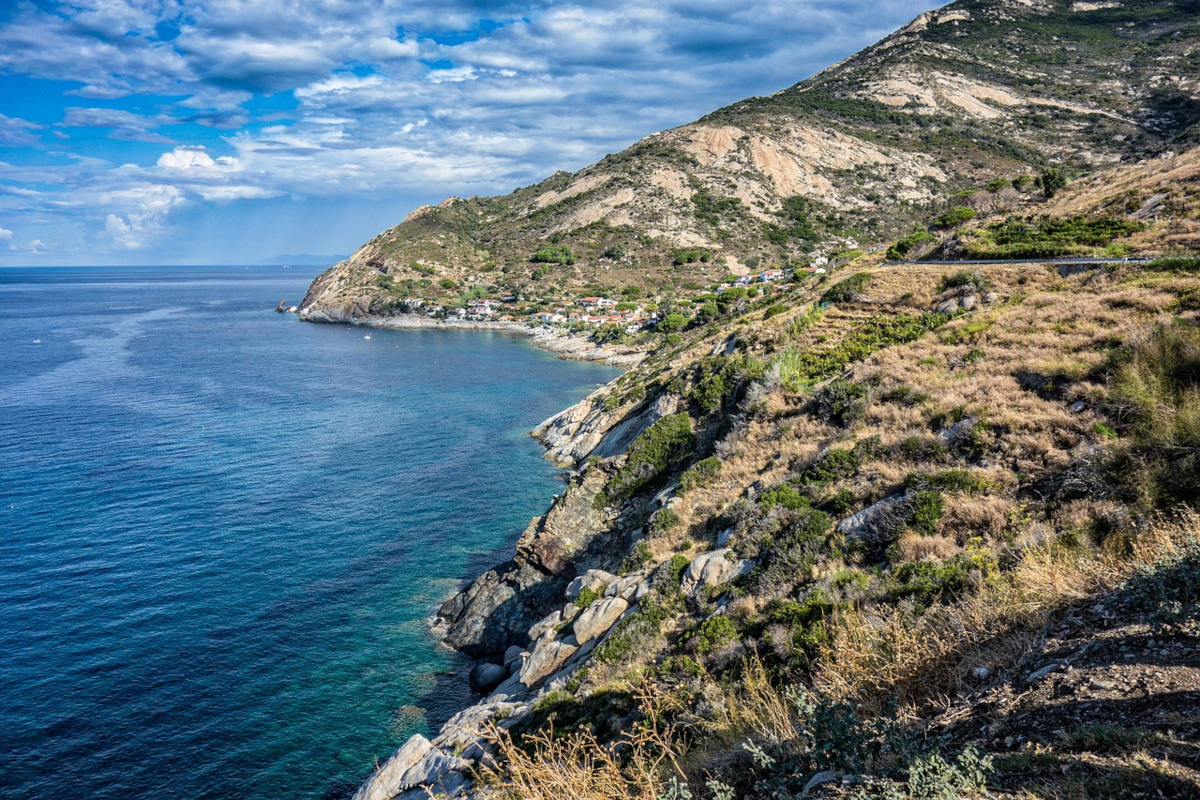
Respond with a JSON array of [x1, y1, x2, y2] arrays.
[[301, 0, 1200, 320]]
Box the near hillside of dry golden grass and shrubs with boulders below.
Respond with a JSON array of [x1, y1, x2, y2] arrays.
[[345, 140, 1200, 800]]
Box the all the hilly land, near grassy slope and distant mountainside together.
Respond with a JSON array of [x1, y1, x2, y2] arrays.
[[314, 0, 1200, 800]]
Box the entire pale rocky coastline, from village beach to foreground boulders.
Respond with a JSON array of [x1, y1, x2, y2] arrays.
[[300, 308, 638, 800]]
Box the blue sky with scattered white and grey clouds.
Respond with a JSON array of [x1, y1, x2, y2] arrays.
[[0, 0, 940, 265]]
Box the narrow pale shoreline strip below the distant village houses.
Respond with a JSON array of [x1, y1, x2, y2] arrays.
[[300, 308, 646, 367]]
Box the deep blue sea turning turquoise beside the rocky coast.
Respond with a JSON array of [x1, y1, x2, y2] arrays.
[[0, 266, 617, 800]]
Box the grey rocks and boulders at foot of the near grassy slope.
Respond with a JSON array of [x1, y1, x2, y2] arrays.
[[354, 387, 715, 800]]
